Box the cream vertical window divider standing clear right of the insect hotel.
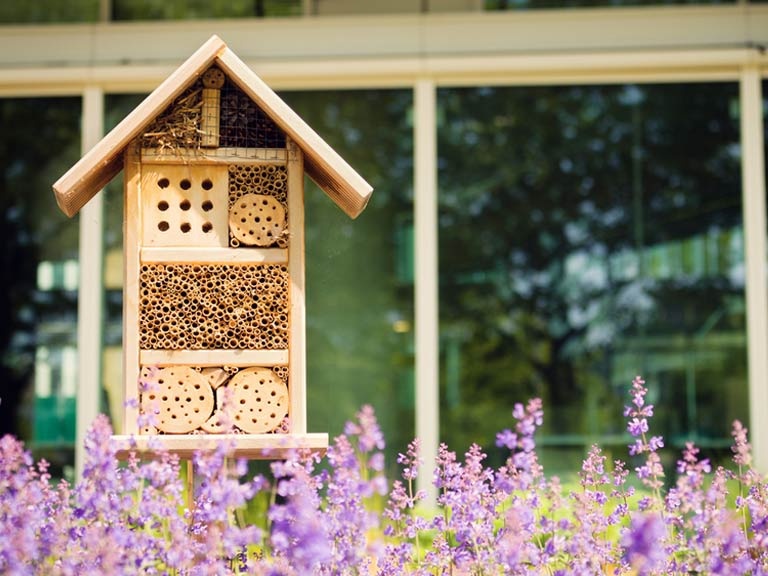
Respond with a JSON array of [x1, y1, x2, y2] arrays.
[[413, 78, 440, 507]]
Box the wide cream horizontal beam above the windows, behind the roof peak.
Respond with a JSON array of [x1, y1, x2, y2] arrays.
[[0, 3, 768, 68]]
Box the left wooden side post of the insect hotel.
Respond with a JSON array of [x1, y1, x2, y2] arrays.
[[123, 145, 141, 434]]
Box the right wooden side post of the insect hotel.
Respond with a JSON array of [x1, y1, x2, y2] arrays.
[[286, 139, 307, 434]]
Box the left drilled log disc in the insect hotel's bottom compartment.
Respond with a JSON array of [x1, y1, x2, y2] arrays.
[[146, 366, 213, 434]]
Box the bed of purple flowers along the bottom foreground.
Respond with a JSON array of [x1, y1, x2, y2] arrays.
[[0, 378, 768, 576]]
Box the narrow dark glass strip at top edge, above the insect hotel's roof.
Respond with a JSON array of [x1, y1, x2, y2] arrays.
[[112, 0, 302, 20]]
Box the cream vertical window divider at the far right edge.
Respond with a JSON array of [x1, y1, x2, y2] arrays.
[[739, 63, 768, 472]]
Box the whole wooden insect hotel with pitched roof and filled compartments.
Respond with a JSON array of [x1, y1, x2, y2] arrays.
[[53, 36, 372, 458]]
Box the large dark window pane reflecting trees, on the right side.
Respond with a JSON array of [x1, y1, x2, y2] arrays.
[[439, 84, 748, 471]]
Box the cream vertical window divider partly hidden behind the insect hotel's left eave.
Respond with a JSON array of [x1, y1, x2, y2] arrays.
[[75, 86, 104, 479]]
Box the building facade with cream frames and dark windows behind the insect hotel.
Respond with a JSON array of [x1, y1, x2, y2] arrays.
[[0, 0, 768, 500]]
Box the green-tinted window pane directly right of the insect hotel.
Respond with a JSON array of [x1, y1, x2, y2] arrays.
[[282, 90, 414, 463]]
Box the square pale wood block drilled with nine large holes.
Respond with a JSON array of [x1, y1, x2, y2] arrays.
[[141, 165, 229, 247]]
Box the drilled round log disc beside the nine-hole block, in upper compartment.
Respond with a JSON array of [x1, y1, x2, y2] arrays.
[[229, 194, 285, 246]]
